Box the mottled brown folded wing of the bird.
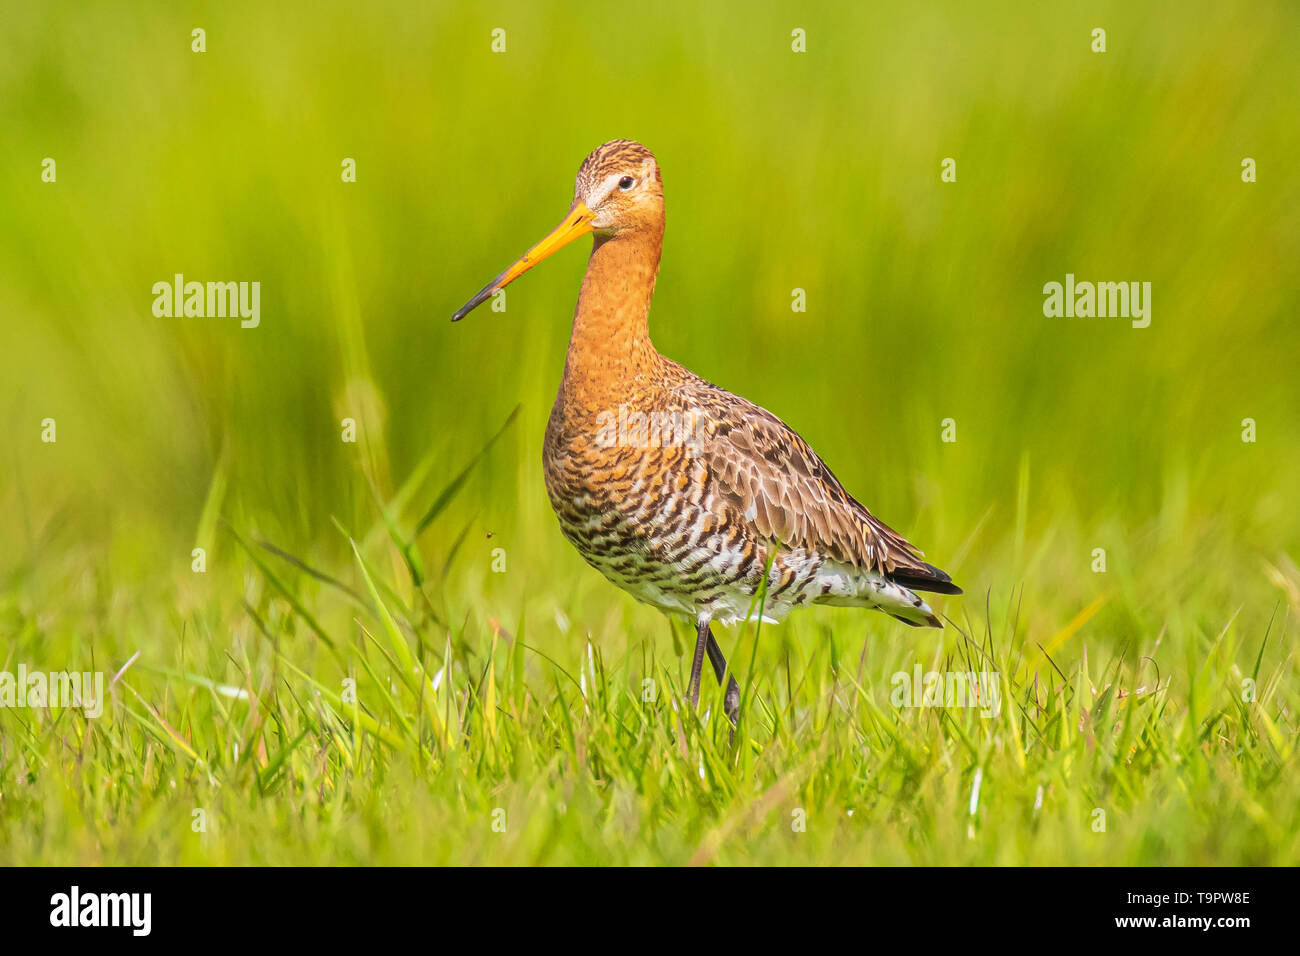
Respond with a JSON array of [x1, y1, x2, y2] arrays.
[[699, 386, 948, 583]]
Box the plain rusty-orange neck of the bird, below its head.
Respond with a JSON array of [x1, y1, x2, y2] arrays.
[[560, 226, 663, 411]]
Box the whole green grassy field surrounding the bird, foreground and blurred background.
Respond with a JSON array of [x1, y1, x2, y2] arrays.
[[0, 0, 1300, 865]]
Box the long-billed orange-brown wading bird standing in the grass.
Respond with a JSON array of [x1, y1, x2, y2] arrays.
[[452, 139, 962, 726]]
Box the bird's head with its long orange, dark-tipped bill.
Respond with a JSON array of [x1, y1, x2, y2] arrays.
[[451, 139, 663, 321]]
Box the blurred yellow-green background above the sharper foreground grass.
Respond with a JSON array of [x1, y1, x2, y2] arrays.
[[0, 0, 1300, 868]]
